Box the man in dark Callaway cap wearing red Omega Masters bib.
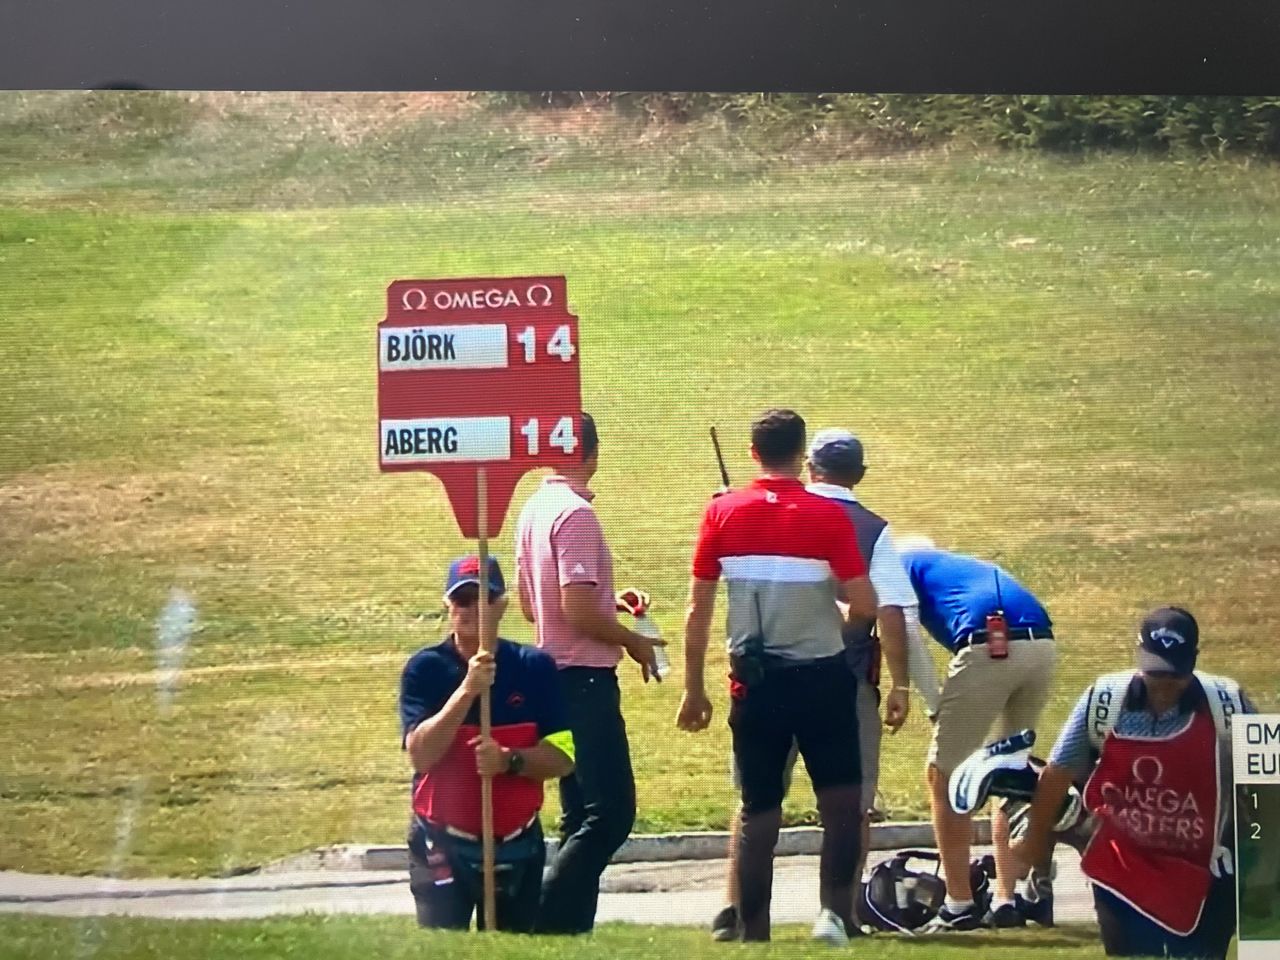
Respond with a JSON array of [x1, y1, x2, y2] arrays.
[[1012, 607, 1254, 960]]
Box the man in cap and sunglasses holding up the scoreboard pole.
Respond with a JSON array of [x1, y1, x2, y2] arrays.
[[399, 557, 573, 933]]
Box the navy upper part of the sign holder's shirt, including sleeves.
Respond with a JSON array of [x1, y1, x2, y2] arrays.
[[399, 637, 568, 786]]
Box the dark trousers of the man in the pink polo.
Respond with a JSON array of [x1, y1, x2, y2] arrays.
[[538, 667, 636, 933]]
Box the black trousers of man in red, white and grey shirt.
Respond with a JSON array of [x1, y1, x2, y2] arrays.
[[728, 654, 863, 940]]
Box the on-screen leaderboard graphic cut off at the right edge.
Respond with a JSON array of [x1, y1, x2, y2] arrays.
[[1231, 714, 1280, 960]]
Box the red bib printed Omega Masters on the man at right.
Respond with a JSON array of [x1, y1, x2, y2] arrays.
[[1080, 710, 1220, 937]]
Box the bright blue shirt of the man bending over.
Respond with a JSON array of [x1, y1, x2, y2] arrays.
[[902, 549, 1053, 652]]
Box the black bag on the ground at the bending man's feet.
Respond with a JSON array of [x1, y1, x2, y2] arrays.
[[854, 850, 996, 934]]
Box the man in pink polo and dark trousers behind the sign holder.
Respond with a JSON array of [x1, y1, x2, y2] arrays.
[[516, 413, 662, 933]]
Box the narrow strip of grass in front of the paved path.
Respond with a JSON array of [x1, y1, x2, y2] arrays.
[[0, 916, 1121, 960]]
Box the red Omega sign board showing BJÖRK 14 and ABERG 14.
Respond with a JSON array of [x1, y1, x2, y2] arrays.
[[378, 276, 582, 538]]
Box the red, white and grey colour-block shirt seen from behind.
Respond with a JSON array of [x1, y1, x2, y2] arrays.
[[692, 476, 867, 660]]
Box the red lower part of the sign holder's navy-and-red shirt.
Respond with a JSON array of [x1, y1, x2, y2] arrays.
[[413, 723, 543, 838]]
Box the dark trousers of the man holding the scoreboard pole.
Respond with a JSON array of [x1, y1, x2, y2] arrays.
[[408, 817, 547, 933]]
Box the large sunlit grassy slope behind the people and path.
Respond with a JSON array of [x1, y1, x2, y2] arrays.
[[0, 95, 1280, 880]]
